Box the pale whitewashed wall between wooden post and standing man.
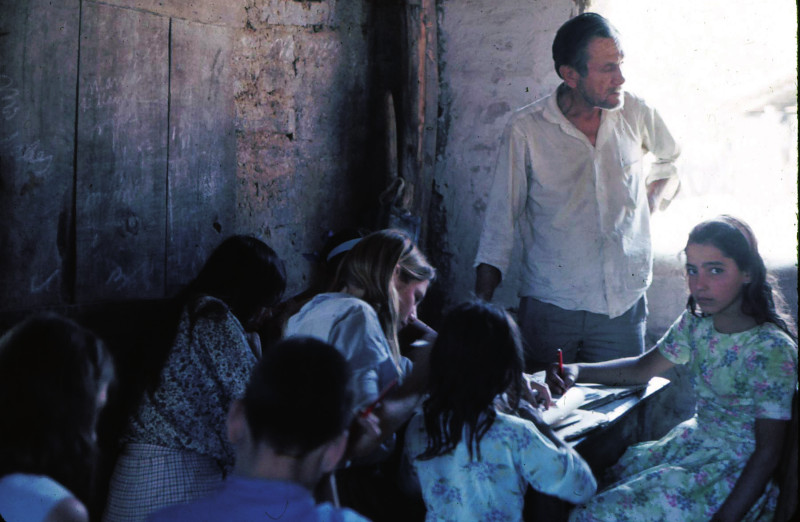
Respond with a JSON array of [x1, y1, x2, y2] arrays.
[[432, 0, 581, 308]]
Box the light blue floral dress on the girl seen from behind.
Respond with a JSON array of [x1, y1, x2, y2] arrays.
[[405, 412, 597, 522]]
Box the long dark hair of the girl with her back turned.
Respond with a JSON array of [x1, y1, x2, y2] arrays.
[[417, 301, 524, 460]]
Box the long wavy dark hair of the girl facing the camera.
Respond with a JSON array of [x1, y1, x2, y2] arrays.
[[686, 215, 797, 340]]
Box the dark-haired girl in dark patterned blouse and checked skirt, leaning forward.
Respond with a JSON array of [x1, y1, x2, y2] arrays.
[[104, 236, 286, 521]]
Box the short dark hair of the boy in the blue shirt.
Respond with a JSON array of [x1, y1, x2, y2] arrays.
[[243, 337, 353, 457]]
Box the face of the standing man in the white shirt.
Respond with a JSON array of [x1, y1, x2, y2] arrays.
[[575, 38, 625, 109]]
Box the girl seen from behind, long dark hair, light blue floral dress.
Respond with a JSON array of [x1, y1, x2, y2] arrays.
[[405, 302, 597, 520]]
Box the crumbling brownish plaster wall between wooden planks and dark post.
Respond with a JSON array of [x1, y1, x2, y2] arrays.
[[233, 0, 369, 294]]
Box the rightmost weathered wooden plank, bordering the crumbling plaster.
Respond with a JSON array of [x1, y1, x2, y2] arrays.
[[166, 20, 236, 294]]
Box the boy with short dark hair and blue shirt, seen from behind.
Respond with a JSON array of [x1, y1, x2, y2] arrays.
[[150, 337, 366, 522]]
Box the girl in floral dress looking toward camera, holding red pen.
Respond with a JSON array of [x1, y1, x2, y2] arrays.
[[548, 216, 797, 521]]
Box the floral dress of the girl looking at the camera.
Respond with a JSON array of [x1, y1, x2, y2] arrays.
[[570, 311, 797, 522]]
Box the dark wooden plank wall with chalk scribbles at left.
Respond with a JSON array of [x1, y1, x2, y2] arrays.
[[0, 0, 236, 311]]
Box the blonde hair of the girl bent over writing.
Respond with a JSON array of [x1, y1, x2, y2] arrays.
[[334, 229, 436, 371]]
